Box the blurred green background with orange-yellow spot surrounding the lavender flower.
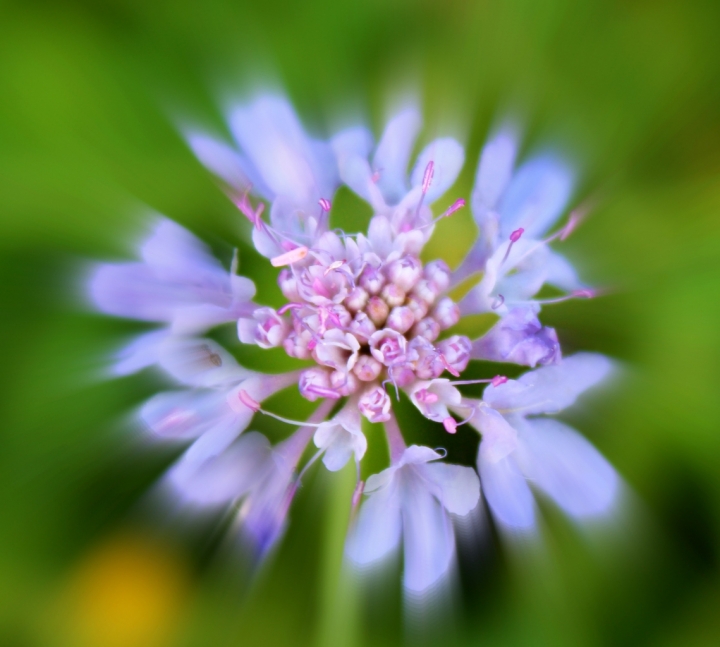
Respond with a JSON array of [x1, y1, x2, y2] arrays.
[[0, 0, 720, 647]]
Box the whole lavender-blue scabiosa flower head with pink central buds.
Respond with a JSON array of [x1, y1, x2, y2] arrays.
[[90, 95, 619, 595]]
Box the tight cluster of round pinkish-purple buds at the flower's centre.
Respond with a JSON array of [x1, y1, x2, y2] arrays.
[[238, 246, 472, 422]]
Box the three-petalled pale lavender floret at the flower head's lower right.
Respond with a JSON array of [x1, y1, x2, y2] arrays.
[[470, 353, 620, 530]]
